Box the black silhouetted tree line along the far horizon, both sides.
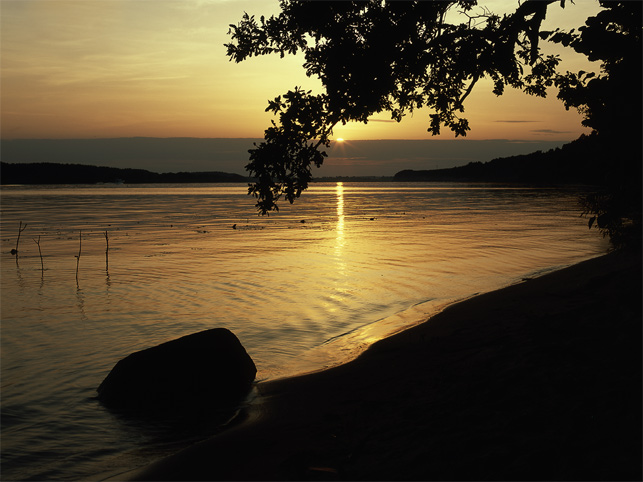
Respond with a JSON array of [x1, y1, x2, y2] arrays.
[[0, 134, 632, 186]]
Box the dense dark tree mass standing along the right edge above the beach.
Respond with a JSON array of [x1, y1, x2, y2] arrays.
[[542, 1, 643, 248]]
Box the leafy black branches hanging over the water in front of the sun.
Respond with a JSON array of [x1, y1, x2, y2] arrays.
[[226, 0, 640, 237]]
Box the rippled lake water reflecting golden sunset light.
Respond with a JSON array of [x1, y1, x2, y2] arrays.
[[1, 183, 607, 480]]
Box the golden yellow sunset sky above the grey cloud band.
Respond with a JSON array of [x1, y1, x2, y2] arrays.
[[0, 0, 598, 141]]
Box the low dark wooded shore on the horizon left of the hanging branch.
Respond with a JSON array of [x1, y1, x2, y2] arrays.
[[0, 162, 248, 184]]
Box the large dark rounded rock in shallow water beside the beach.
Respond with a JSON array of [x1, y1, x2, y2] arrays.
[[98, 328, 257, 410]]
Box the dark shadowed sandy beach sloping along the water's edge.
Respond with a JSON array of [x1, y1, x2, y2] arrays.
[[127, 253, 642, 480]]
